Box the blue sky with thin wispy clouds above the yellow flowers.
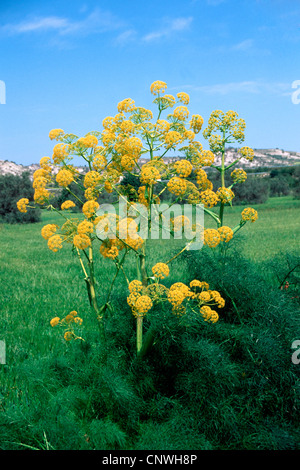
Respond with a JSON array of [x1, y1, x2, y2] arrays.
[[0, 0, 300, 165]]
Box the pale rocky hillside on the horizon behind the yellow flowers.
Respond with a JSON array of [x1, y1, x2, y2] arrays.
[[0, 147, 300, 175]]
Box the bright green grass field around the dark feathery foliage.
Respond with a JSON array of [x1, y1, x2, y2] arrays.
[[0, 196, 300, 449]]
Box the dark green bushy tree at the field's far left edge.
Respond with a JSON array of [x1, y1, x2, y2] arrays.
[[0, 172, 41, 224]]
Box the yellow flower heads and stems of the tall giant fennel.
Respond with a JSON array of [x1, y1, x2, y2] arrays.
[[17, 81, 257, 356]]
